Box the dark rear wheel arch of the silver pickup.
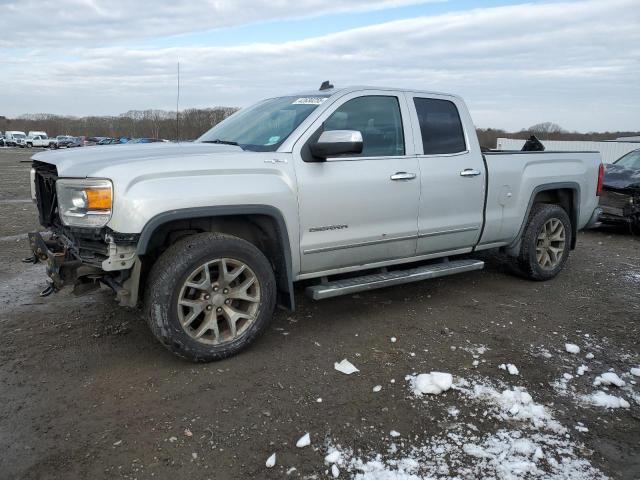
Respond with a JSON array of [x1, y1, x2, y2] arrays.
[[506, 182, 580, 256]]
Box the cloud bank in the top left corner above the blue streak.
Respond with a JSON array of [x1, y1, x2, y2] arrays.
[[0, 0, 436, 48]]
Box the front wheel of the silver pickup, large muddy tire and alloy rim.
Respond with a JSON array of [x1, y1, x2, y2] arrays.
[[144, 233, 276, 362]]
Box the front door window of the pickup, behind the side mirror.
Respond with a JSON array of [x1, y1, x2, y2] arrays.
[[324, 96, 404, 157]]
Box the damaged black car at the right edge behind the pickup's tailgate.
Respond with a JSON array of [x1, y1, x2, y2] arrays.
[[600, 149, 640, 234]]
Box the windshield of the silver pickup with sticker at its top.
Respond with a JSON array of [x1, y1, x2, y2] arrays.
[[197, 95, 329, 152]]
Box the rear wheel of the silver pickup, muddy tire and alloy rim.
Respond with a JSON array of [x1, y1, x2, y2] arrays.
[[517, 204, 573, 281]]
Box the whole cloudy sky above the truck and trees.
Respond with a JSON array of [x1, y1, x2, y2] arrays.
[[0, 0, 640, 131]]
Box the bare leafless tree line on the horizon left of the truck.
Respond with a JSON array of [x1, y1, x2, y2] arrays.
[[0, 107, 238, 140]]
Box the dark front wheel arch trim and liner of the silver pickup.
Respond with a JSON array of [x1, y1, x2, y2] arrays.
[[136, 205, 295, 310]]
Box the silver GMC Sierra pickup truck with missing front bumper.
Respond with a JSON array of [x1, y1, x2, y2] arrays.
[[30, 84, 603, 361]]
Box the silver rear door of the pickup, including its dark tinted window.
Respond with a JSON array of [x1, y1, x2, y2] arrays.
[[407, 93, 486, 255]]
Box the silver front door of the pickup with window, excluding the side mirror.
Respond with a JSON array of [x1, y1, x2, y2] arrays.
[[293, 90, 420, 274]]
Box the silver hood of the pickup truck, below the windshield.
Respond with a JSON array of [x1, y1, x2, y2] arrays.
[[31, 142, 243, 178]]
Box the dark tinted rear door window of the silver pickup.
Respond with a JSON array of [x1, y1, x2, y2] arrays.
[[413, 98, 467, 155]]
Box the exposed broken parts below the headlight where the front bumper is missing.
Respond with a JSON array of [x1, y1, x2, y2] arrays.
[[25, 232, 141, 307]]
